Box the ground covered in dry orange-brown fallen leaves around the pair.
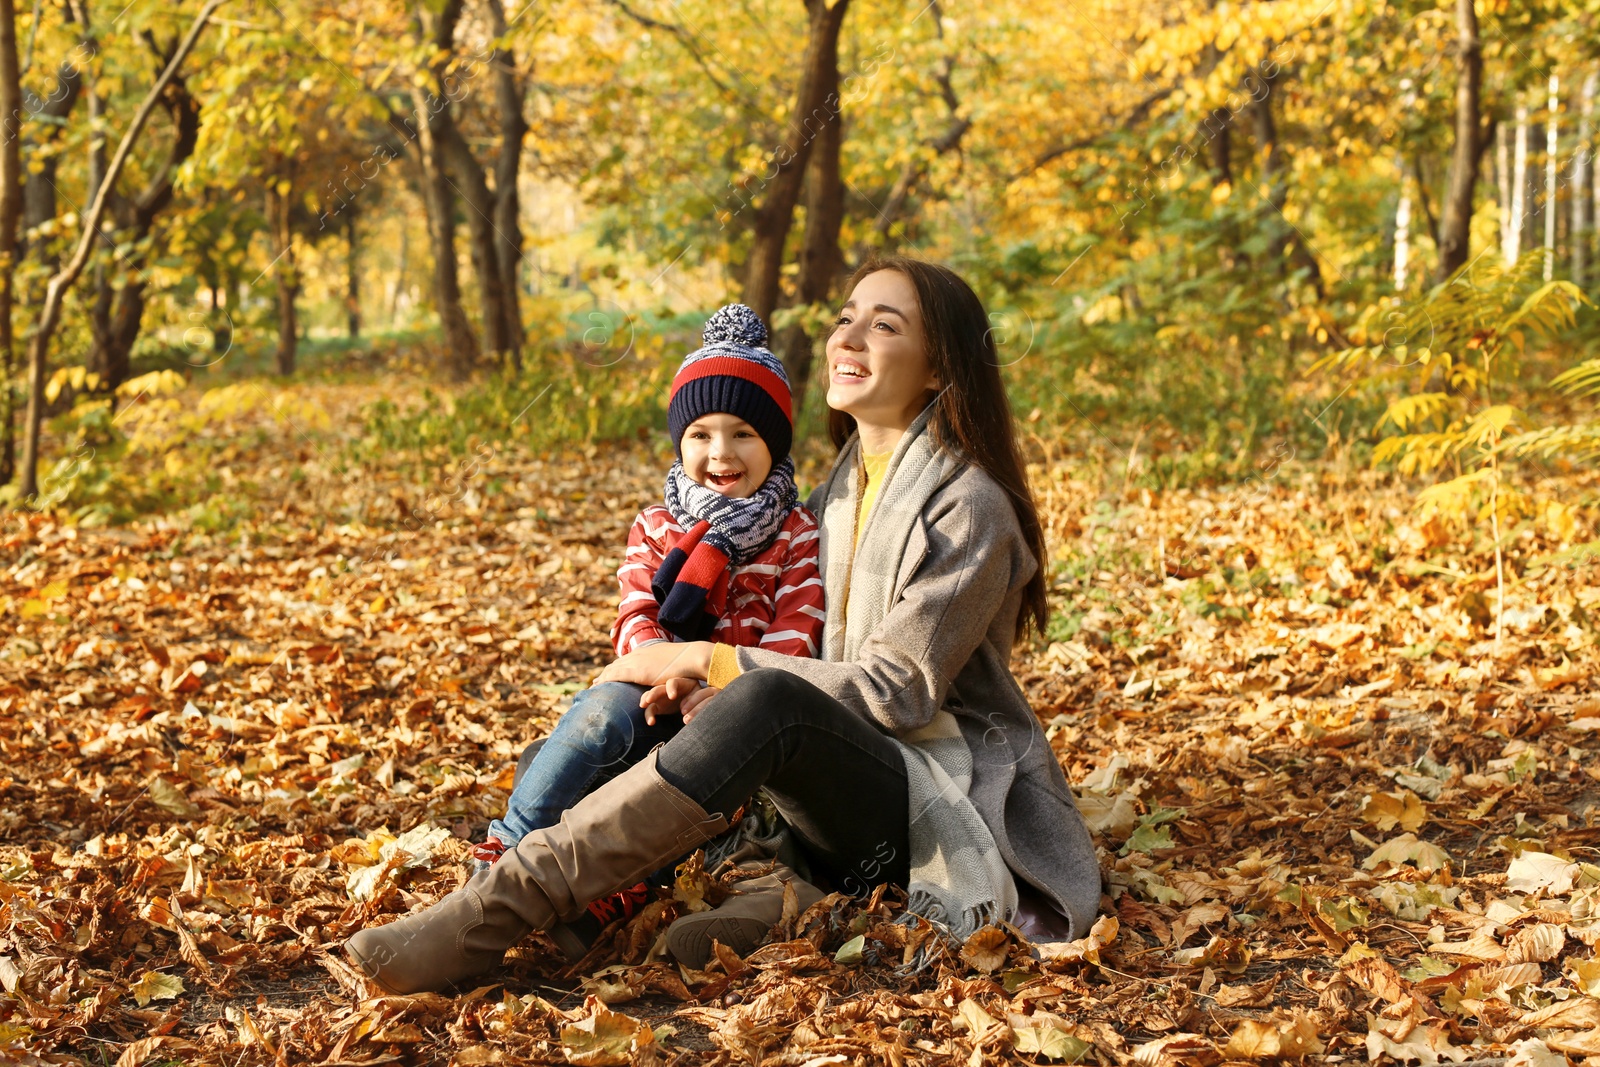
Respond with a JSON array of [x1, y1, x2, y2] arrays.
[[0, 379, 1600, 1067]]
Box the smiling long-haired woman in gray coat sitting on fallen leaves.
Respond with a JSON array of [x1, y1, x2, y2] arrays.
[[346, 258, 1101, 993]]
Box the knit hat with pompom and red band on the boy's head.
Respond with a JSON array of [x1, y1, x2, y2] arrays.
[[667, 304, 795, 467]]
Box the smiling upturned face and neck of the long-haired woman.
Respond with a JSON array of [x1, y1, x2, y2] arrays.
[[827, 270, 939, 451]]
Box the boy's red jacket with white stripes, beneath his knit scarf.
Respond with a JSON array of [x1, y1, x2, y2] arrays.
[[611, 504, 824, 659]]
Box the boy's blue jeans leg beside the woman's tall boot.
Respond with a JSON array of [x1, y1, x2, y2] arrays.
[[490, 681, 683, 848]]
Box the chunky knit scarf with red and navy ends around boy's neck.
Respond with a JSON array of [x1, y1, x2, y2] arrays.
[[650, 456, 800, 641]]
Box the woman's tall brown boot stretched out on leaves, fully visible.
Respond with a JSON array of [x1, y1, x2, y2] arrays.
[[344, 752, 728, 993]]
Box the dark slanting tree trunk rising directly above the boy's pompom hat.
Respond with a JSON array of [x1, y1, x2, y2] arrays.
[[744, 0, 850, 320]]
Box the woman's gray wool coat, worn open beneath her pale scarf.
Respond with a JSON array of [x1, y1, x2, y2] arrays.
[[736, 448, 1101, 937]]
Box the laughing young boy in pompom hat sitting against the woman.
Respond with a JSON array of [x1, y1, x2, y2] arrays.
[[474, 304, 824, 947]]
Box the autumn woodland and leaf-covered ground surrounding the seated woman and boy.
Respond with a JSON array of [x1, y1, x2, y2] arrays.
[[0, 0, 1600, 1067]]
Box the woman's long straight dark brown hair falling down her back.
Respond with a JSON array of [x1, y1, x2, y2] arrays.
[[827, 256, 1050, 640]]
